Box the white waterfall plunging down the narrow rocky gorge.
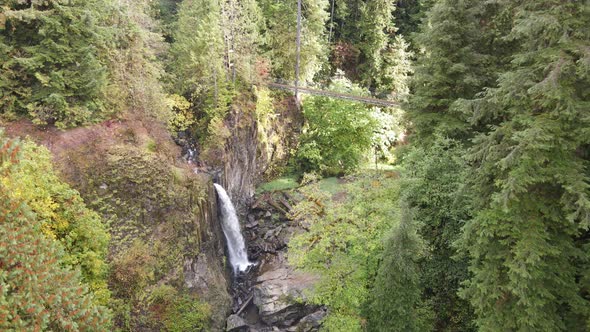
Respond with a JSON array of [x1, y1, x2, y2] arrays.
[[213, 183, 252, 273]]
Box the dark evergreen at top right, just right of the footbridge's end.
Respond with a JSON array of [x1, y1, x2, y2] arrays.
[[407, 0, 505, 145]]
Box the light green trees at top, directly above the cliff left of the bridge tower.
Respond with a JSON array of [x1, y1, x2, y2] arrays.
[[169, 0, 260, 143]]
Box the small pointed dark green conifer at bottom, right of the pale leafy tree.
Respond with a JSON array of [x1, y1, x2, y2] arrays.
[[367, 207, 432, 332]]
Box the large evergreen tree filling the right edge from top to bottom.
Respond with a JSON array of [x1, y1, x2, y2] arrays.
[[461, 0, 590, 331]]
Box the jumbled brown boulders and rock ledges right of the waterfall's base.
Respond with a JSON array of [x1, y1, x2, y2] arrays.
[[227, 192, 326, 332]]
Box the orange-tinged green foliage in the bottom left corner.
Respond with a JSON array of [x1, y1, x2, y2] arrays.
[[0, 134, 110, 331]]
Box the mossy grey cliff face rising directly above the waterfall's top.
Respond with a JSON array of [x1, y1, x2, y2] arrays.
[[215, 93, 303, 217]]
